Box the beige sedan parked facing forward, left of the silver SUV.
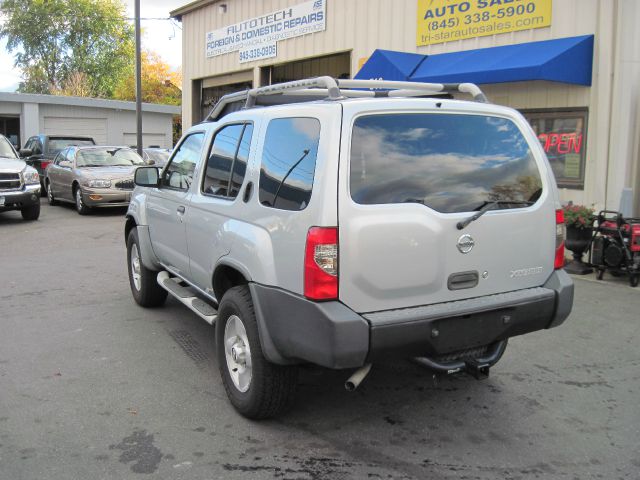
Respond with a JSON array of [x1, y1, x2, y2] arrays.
[[45, 146, 144, 215]]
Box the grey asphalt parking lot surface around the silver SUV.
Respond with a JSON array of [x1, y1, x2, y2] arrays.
[[0, 199, 640, 480]]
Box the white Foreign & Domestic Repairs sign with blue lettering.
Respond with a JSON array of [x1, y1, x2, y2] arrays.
[[206, 0, 326, 59]]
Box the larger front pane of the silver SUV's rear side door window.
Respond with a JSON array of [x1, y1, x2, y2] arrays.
[[202, 124, 245, 198]]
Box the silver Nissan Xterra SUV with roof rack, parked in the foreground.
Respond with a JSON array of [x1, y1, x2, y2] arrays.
[[125, 77, 573, 418]]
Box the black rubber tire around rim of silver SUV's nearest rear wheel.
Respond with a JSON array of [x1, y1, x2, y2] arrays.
[[216, 285, 298, 420]]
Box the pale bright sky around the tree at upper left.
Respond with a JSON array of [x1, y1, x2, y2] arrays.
[[0, 0, 186, 92]]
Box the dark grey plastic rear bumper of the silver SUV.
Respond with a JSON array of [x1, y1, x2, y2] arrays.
[[251, 270, 573, 368]]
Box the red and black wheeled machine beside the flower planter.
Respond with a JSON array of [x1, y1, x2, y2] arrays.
[[590, 210, 640, 287]]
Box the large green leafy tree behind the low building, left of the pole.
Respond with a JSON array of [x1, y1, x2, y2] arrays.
[[0, 0, 134, 97]]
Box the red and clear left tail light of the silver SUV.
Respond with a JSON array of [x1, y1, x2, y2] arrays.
[[304, 227, 338, 300]]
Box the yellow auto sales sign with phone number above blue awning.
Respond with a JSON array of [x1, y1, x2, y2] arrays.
[[416, 0, 551, 46]]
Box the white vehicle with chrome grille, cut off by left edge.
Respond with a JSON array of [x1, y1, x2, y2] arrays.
[[0, 135, 40, 220]]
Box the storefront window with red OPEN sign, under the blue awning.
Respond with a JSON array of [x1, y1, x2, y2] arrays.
[[522, 109, 588, 189]]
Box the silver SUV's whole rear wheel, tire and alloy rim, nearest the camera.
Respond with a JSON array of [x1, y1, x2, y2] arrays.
[[216, 285, 298, 420]]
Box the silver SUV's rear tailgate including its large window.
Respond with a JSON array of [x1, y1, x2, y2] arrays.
[[338, 99, 555, 312]]
